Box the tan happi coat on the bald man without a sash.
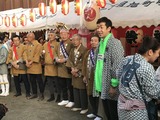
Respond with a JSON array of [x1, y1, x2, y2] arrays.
[[26, 40, 42, 74]]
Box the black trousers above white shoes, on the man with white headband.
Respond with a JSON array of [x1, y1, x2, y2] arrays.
[[58, 77, 74, 102]]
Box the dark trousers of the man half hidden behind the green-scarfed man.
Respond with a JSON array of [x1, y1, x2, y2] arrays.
[[88, 95, 99, 115]]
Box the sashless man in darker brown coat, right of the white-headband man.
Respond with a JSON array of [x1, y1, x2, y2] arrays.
[[66, 34, 88, 114]]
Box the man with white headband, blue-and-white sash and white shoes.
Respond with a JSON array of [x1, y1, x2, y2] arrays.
[[56, 29, 74, 107]]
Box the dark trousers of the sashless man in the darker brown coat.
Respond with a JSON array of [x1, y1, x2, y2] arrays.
[[73, 88, 88, 110]]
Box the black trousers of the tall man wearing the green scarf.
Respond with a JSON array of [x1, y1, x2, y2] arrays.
[[102, 99, 118, 120]]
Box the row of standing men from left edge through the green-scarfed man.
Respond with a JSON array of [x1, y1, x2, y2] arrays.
[[0, 17, 124, 120]]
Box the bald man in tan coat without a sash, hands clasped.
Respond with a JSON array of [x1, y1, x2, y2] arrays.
[[26, 33, 44, 100]]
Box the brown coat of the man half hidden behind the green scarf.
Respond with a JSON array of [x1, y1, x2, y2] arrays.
[[82, 50, 94, 95]]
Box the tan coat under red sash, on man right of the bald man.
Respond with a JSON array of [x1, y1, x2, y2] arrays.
[[43, 41, 58, 76]]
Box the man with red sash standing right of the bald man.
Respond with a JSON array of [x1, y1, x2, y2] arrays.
[[42, 31, 60, 102]]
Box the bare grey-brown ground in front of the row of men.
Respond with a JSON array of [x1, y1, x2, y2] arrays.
[[0, 81, 106, 120]]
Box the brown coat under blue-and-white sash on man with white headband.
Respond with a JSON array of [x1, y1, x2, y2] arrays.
[[58, 39, 73, 78]]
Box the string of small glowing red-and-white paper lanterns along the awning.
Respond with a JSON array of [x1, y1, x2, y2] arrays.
[[0, 0, 117, 27]]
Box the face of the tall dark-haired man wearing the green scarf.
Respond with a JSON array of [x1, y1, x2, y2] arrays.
[[97, 22, 111, 38]]
